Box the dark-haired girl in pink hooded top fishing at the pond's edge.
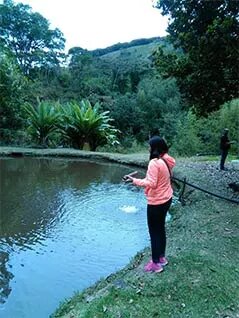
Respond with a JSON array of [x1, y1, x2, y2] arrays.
[[123, 136, 175, 273]]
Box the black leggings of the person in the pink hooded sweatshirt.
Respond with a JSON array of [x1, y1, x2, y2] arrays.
[[147, 198, 172, 263]]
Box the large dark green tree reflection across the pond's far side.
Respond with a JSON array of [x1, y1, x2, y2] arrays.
[[0, 158, 133, 246]]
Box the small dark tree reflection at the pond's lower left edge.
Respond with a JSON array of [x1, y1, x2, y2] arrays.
[[0, 251, 14, 304]]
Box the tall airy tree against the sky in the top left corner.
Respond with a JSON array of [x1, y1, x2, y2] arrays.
[[0, 0, 65, 75]]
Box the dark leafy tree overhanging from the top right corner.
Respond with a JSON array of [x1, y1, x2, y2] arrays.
[[154, 0, 239, 115]]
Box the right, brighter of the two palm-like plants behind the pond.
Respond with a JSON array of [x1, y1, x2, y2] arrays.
[[60, 100, 118, 151]]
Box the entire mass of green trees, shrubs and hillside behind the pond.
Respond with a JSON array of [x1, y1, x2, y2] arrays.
[[0, 0, 238, 155]]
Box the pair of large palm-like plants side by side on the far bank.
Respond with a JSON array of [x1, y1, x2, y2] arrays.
[[24, 100, 118, 151]]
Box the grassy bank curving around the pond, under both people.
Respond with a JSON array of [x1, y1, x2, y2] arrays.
[[0, 149, 239, 318]]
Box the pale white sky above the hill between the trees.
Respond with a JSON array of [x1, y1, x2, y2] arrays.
[[14, 0, 167, 51]]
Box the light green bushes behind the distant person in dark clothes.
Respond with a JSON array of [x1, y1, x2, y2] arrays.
[[173, 99, 239, 156]]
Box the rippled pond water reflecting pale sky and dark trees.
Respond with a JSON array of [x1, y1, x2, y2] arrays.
[[0, 158, 152, 318]]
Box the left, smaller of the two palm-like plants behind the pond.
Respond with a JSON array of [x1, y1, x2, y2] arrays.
[[24, 102, 60, 146]]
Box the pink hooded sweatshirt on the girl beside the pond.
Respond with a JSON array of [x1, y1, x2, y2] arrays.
[[133, 153, 175, 205]]
